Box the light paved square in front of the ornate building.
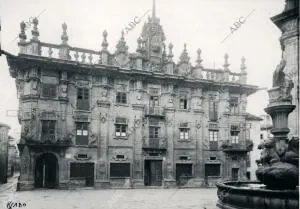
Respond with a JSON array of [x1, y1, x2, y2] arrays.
[[0, 180, 217, 209]]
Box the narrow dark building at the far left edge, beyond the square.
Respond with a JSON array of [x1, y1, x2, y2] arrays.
[[0, 123, 10, 183]]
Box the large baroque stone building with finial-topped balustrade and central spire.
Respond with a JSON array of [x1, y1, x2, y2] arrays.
[[7, 0, 258, 190]]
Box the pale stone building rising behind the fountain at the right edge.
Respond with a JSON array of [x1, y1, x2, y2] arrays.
[[271, 0, 300, 138]]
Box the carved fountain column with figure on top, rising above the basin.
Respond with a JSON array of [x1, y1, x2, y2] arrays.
[[256, 60, 299, 190]]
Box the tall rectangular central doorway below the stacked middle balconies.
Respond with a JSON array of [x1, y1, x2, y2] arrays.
[[144, 160, 162, 186]]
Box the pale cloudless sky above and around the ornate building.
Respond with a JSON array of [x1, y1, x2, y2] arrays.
[[0, 0, 284, 138]]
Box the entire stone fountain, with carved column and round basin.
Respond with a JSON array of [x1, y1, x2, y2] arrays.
[[217, 60, 299, 209]]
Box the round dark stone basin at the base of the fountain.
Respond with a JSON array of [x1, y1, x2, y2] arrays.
[[216, 181, 299, 209]]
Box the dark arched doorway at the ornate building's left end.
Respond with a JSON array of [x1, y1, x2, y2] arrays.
[[35, 153, 58, 188]]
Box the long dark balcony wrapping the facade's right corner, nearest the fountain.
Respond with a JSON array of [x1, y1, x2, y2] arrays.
[[221, 140, 253, 152]]
